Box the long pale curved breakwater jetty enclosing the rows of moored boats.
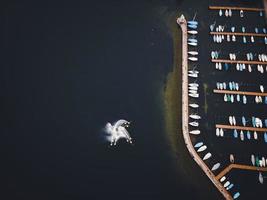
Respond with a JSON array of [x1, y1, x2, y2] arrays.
[[177, 15, 233, 199]]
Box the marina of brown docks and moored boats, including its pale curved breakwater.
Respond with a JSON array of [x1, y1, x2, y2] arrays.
[[177, 1, 267, 199]]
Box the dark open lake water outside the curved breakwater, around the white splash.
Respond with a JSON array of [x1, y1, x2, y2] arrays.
[[0, 0, 266, 200]]
